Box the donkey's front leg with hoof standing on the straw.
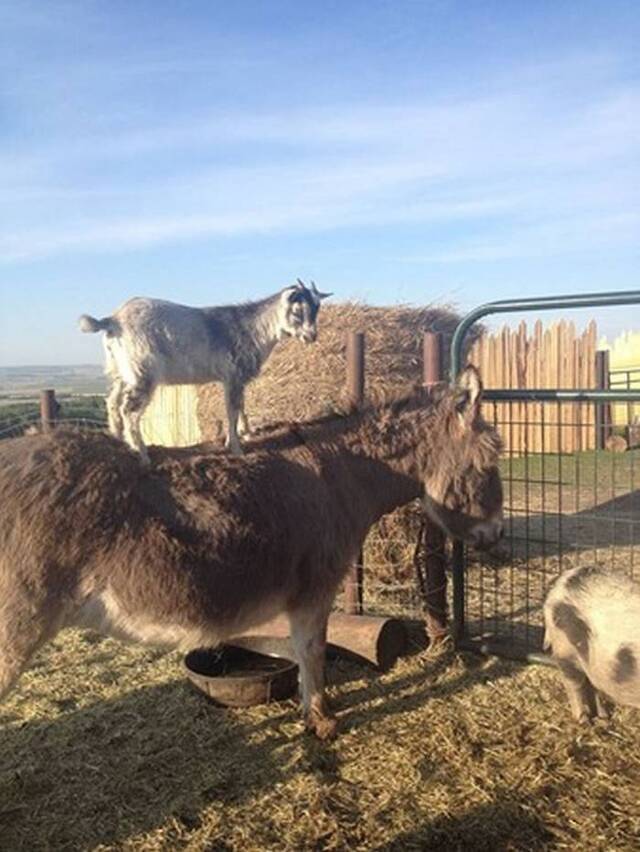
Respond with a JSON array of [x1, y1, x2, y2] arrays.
[[289, 603, 336, 740]]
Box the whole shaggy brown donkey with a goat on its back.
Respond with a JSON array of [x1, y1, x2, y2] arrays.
[[0, 368, 502, 737]]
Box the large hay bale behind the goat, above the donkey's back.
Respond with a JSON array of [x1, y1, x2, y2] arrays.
[[198, 302, 480, 441]]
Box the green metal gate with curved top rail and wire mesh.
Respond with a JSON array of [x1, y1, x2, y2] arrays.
[[451, 291, 640, 661]]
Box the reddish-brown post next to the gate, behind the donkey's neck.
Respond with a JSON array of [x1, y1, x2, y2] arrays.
[[421, 331, 448, 645]]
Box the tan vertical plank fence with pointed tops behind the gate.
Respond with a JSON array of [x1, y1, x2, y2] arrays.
[[469, 320, 597, 455]]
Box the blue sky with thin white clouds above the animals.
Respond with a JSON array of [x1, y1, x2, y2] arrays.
[[0, 0, 640, 365]]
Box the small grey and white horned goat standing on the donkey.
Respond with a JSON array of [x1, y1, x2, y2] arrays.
[[79, 279, 331, 462]]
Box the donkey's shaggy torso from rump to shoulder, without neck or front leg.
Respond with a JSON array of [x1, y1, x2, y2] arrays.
[[0, 430, 355, 694]]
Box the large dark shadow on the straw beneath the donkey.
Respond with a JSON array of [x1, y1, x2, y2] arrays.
[[0, 652, 508, 852]]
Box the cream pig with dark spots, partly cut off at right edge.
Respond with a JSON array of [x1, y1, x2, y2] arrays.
[[544, 565, 640, 722]]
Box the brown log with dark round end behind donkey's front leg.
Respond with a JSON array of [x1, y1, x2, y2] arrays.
[[232, 612, 407, 671]]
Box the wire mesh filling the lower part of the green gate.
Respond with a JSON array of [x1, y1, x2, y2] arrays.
[[464, 402, 640, 656]]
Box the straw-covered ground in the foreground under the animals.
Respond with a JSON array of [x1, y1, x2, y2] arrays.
[[0, 631, 640, 852]]
